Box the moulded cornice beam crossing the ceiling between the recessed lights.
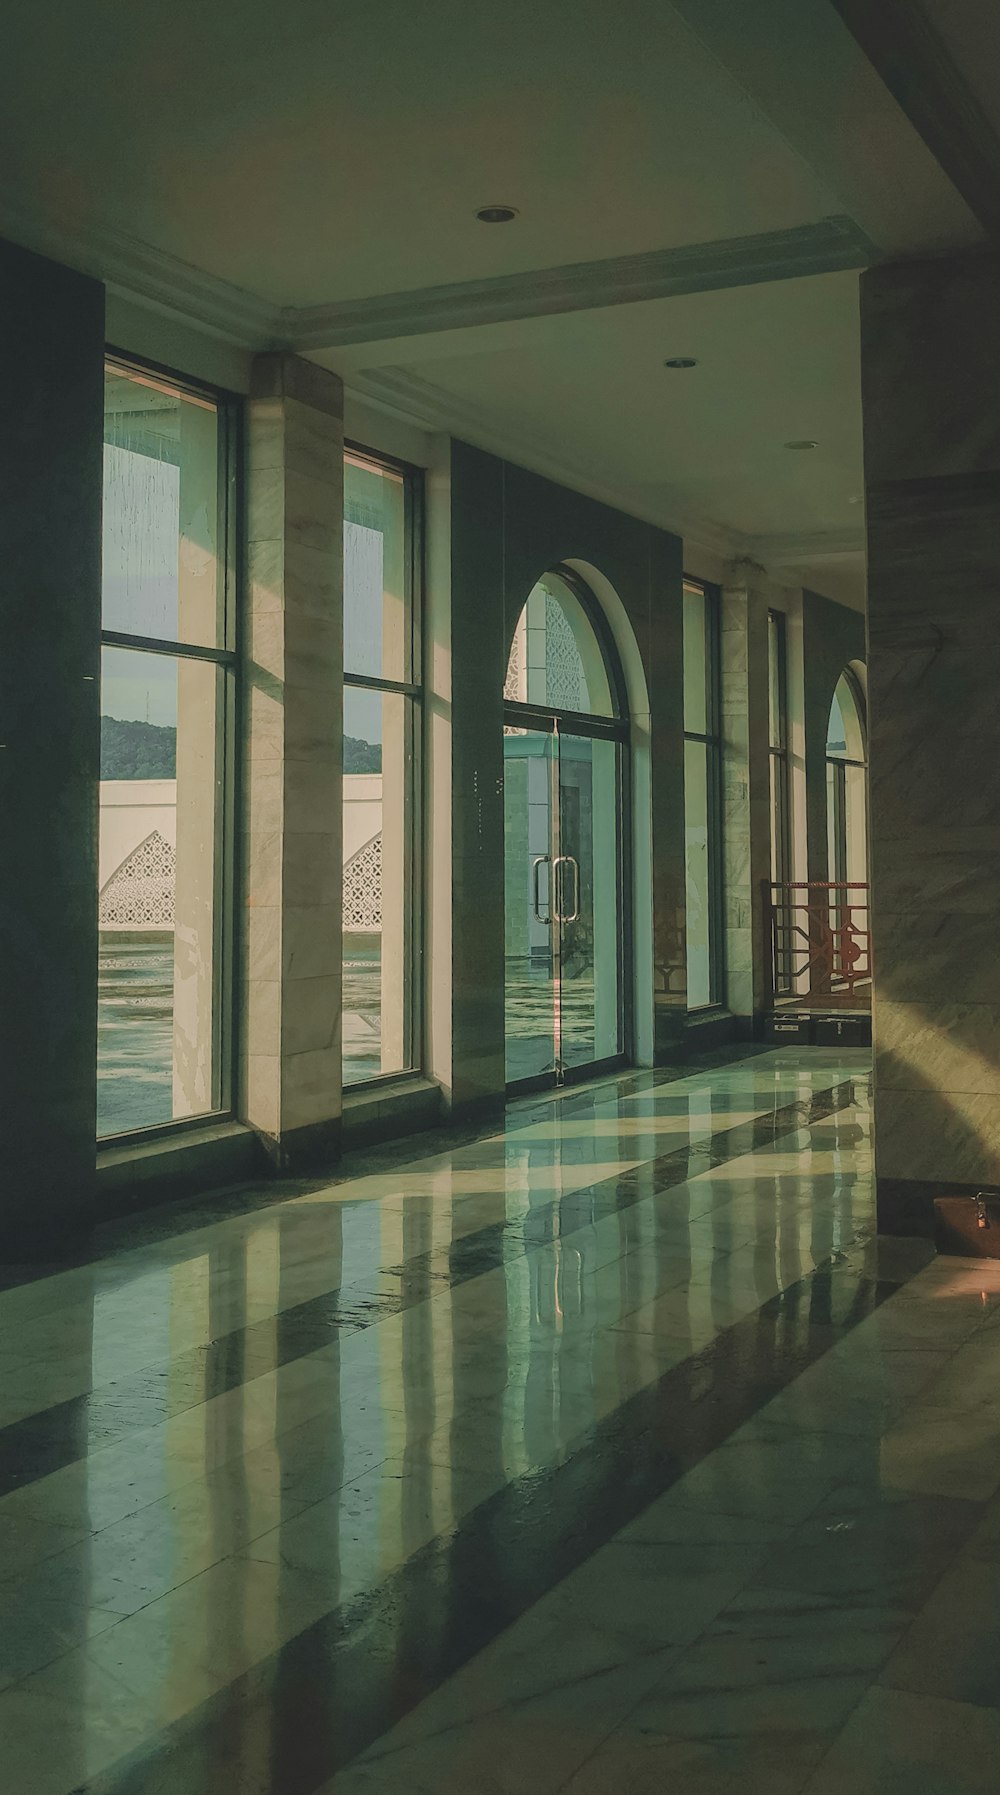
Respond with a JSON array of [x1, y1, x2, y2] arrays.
[[282, 214, 880, 350]]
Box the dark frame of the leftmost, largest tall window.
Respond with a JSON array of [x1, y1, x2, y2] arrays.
[[95, 343, 246, 1152]]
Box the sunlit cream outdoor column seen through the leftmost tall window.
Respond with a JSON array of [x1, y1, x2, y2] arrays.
[[174, 402, 221, 1116]]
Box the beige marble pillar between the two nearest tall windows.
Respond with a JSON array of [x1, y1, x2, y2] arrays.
[[241, 354, 343, 1167]]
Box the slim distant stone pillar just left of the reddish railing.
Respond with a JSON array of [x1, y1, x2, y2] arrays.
[[720, 562, 770, 1034]]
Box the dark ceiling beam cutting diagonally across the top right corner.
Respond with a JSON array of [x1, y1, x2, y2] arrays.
[[833, 0, 1000, 237]]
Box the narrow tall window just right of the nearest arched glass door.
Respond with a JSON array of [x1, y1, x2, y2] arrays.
[[684, 582, 724, 1009]]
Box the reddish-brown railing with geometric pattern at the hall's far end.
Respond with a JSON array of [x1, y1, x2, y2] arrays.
[[765, 880, 871, 1009]]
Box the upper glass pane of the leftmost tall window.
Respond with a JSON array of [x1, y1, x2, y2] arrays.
[[102, 368, 224, 648]]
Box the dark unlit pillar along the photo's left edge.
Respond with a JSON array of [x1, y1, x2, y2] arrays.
[[0, 244, 104, 1257]]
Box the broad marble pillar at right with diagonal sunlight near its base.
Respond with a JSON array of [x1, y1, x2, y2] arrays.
[[862, 255, 1000, 1233]]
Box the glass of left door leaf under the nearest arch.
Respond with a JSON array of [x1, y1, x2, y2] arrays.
[[503, 729, 555, 1084]]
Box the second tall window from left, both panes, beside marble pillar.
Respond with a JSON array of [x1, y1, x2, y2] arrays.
[[343, 449, 420, 1084]]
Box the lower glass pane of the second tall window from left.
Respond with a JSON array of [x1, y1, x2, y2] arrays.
[[343, 686, 415, 1084]]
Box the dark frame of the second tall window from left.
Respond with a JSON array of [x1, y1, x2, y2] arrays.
[[341, 438, 427, 1095]]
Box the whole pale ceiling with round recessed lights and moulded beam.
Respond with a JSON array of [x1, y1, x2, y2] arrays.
[[0, 0, 984, 598]]
